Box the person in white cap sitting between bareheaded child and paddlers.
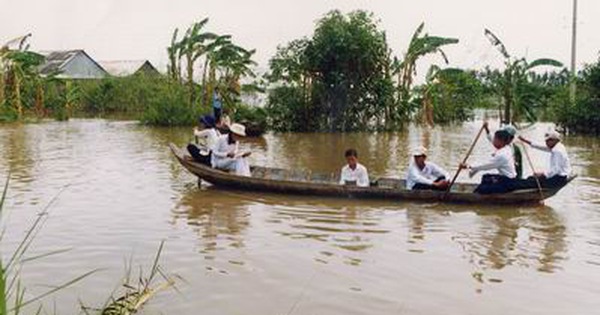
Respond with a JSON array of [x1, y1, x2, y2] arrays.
[[406, 147, 450, 190]]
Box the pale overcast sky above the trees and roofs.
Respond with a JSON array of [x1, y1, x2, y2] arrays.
[[0, 0, 600, 76]]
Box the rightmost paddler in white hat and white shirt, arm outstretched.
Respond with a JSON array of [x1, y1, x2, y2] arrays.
[[519, 130, 571, 188]]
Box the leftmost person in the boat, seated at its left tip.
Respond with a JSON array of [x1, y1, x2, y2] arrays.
[[187, 115, 221, 166]]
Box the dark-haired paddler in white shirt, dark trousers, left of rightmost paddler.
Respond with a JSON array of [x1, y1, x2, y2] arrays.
[[459, 130, 517, 194]]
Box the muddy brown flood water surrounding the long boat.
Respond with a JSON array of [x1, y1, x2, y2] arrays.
[[0, 120, 600, 315]]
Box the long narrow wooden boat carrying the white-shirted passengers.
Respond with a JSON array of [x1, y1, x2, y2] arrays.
[[170, 144, 575, 205]]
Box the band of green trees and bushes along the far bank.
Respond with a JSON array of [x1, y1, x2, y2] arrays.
[[0, 11, 600, 134]]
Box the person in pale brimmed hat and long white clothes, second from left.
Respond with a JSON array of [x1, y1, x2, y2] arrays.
[[212, 124, 251, 176]]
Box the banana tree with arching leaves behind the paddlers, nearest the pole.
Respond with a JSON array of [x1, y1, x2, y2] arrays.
[[484, 29, 563, 124]]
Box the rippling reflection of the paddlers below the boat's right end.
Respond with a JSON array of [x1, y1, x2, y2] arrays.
[[452, 207, 567, 273]]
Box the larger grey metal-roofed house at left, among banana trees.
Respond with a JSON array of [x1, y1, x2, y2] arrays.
[[40, 49, 108, 79]]
